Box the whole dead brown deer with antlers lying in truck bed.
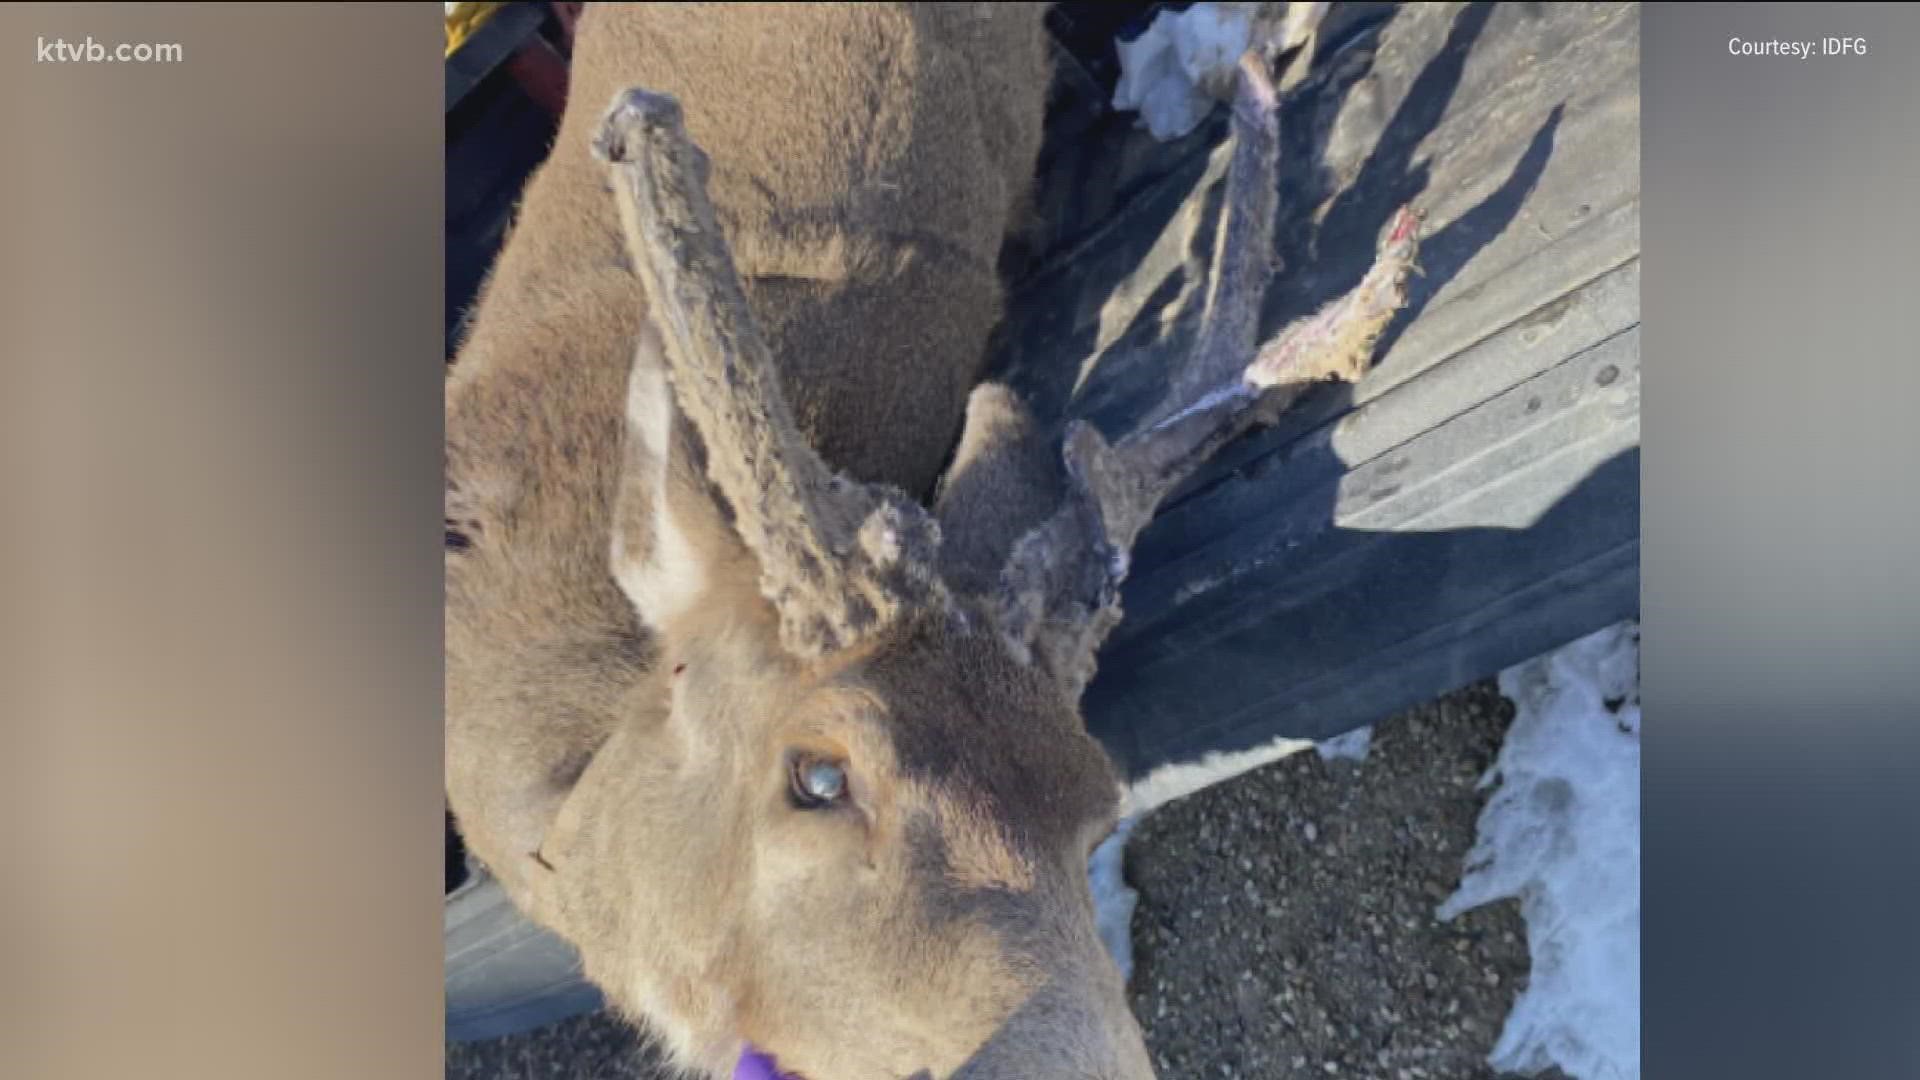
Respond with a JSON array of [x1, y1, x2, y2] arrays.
[[447, 4, 1413, 1080]]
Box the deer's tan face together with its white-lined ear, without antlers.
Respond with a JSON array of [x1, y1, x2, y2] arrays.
[[541, 282, 1152, 1080]]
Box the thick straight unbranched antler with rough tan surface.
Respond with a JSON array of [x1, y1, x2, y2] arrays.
[[593, 90, 945, 657]]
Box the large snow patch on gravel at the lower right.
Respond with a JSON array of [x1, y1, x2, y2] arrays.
[[1436, 623, 1640, 1080]]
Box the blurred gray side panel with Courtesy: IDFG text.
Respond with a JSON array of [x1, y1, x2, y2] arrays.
[[1642, 4, 1920, 1080]]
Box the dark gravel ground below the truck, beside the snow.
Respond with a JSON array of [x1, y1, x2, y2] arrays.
[[447, 682, 1559, 1080]]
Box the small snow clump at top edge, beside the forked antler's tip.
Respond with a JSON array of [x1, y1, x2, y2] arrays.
[[1114, 4, 1260, 142]]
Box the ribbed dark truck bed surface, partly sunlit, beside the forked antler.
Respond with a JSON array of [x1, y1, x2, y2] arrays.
[[1004, 4, 1640, 791]]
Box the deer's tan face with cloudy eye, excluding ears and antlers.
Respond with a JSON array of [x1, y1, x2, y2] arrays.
[[576, 588, 1152, 1080]]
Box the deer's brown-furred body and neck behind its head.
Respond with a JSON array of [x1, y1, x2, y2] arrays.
[[447, 4, 1046, 940]]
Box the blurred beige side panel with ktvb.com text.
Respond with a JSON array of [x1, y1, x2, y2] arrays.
[[0, 4, 444, 1080]]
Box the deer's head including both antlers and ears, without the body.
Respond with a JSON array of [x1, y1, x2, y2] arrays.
[[518, 12, 1413, 1080]]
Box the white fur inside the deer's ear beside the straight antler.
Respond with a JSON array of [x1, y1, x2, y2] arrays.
[[612, 355, 707, 626]]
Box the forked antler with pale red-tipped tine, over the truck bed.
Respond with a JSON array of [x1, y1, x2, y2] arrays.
[[1000, 33, 1417, 692]]
